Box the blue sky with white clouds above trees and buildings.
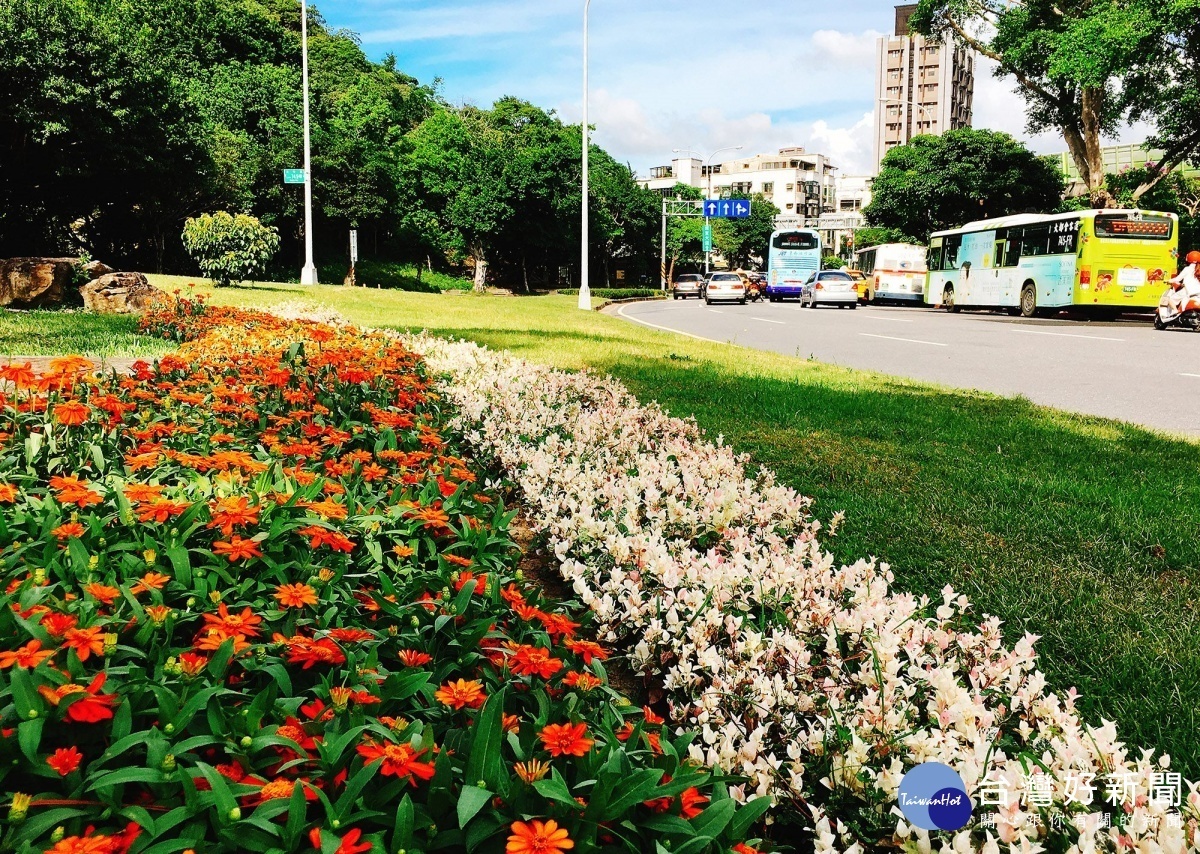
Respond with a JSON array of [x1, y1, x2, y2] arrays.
[[317, 0, 1146, 175]]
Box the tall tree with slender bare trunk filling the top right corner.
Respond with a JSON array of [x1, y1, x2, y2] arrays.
[[910, 0, 1200, 208]]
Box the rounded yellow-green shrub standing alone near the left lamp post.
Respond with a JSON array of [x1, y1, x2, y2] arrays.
[[182, 211, 280, 287]]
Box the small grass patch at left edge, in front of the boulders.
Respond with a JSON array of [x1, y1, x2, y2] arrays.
[[0, 309, 170, 359]]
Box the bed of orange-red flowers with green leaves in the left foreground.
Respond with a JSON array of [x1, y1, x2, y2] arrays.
[[0, 301, 762, 854]]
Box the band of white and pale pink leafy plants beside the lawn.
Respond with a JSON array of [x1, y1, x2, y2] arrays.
[[409, 337, 1200, 852]]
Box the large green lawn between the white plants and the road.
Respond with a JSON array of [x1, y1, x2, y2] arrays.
[[9, 278, 1200, 778]]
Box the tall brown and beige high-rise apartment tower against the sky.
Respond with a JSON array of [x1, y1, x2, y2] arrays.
[[875, 4, 974, 172]]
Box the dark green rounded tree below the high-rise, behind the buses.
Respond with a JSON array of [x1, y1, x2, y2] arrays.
[[858, 127, 1063, 242]]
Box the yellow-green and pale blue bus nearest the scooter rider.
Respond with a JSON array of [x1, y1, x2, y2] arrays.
[[925, 210, 1178, 317]]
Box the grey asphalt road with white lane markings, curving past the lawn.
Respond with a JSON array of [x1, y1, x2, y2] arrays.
[[617, 300, 1200, 435]]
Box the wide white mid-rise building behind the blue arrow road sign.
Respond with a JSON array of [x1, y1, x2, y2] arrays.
[[638, 148, 838, 224]]
